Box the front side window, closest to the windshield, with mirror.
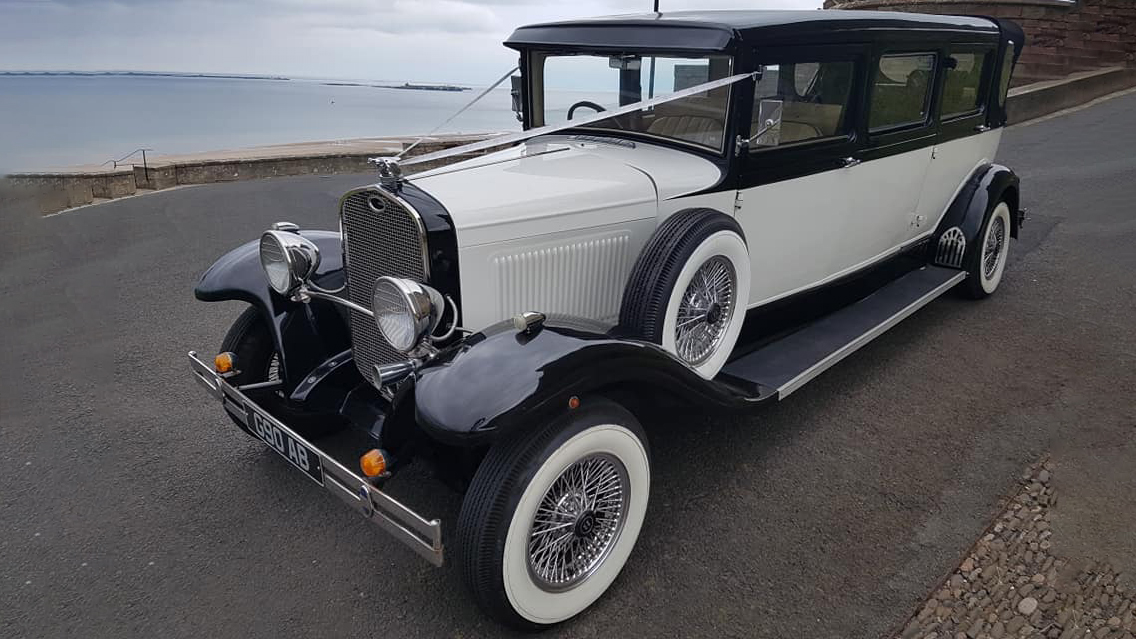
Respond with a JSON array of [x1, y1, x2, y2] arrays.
[[750, 60, 855, 151]]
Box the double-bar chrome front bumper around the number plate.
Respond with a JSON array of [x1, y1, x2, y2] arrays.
[[189, 350, 443, 566]]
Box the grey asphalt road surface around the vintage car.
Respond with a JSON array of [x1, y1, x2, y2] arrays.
[[0, 94, 1136, 639]]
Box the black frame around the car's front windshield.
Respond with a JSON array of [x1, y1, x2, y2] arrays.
[[521, 47, 744, 157]]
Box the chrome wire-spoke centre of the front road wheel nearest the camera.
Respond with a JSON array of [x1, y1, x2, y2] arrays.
[[528, 454, 630, 591]]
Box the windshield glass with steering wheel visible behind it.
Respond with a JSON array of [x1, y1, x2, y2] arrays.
[[532, 53, 730, 151]]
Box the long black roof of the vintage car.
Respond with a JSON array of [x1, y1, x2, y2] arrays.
[[504, 10, 999, 51]]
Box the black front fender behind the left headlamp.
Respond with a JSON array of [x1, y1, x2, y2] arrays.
[[193, 231, 349, 387]]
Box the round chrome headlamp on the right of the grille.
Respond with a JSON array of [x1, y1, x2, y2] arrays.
[[371, 276, 445, 352]]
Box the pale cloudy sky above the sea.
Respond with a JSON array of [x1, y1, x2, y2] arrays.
[[0, 0, 821, 85]]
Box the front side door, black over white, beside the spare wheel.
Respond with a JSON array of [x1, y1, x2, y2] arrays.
[[737, 44, 869, 306]]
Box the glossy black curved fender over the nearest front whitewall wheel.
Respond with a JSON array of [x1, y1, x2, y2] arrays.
[[415, 322, 766, 446]]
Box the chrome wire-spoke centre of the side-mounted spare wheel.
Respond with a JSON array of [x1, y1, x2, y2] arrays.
[[675, 256, 737, 365]]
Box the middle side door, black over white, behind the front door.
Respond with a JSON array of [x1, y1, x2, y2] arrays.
[[837, 49, 939, 267]]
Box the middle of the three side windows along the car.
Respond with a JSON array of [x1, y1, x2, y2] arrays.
[[868, 53, 935, 132]]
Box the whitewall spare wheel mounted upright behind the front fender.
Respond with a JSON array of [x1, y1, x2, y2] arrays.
[[620, 209, 751, 379]]
